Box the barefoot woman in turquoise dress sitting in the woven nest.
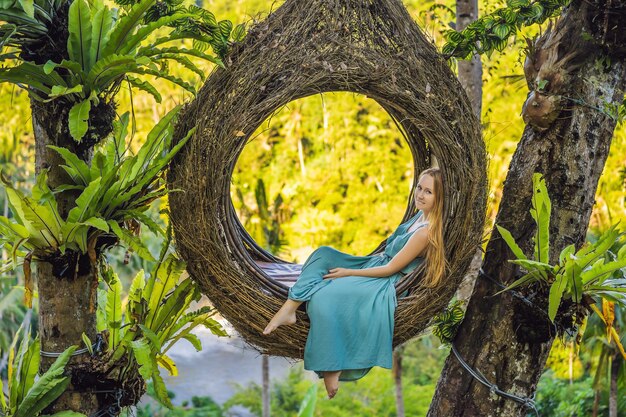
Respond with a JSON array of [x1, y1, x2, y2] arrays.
[[263, 168, 446, 398]]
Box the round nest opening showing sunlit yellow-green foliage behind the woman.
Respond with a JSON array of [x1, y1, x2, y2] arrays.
[[231, 92, 414, 264]]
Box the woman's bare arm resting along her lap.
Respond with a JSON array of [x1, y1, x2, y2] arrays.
[[324, 227, 428, 278]]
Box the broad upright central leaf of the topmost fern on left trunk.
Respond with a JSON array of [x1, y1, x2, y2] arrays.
[[67, 0, 92, 70]]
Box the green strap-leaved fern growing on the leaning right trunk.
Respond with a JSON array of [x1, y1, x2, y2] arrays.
[[496, 173, 626, 358]]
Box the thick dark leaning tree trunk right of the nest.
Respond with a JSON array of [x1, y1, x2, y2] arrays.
[[428, 0, 626, 417]]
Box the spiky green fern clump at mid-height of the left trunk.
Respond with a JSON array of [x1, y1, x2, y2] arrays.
[[0, 107, 193, 304]]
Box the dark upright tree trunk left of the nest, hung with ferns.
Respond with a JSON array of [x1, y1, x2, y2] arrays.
[[22, 7, 115, 415]]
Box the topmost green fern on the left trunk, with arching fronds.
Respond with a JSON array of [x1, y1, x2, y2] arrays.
[[0, 0, 244, 144]]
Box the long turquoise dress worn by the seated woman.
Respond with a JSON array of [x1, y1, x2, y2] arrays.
[[289, 211, 425, 381]]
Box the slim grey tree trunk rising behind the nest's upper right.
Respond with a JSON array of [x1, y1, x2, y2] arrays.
[[456, 0, 483, 120]]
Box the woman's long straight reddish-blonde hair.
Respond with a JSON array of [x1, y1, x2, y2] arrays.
[[419, 168, 448, 288]]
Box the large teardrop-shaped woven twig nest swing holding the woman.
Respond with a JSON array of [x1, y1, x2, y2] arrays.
[[168, 0, 487, 358]]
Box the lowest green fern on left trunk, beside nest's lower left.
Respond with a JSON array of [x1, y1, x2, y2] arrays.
[[92, 236, 227, 408]]
